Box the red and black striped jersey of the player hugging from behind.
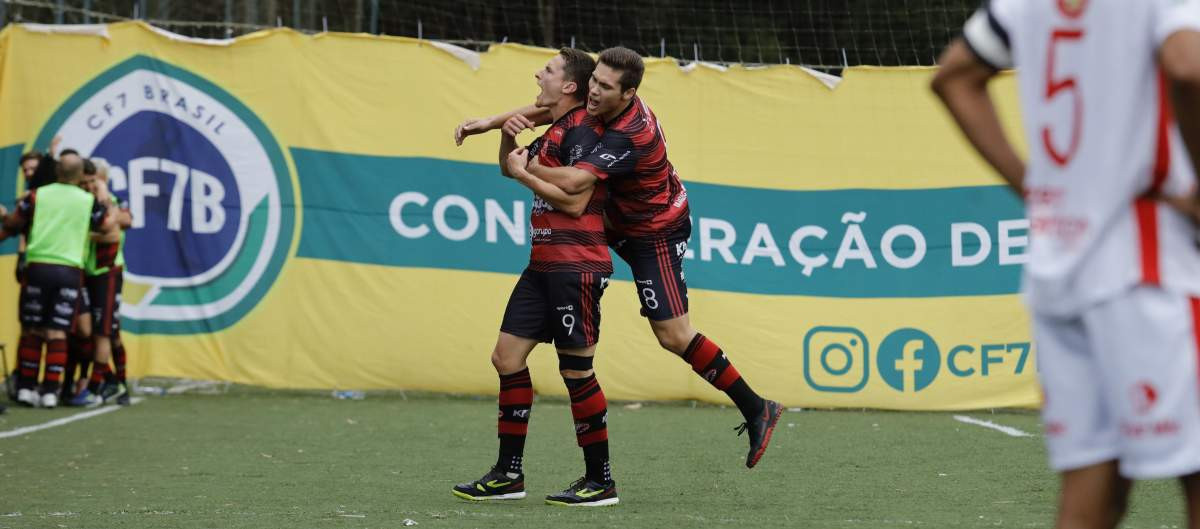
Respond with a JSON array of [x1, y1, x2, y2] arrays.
[[575, 96, 690, 238]]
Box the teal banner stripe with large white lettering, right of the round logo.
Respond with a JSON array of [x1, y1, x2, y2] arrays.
[[292, 149, 1028, 297]]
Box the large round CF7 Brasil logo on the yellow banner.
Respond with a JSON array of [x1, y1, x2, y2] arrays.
[[35, 55, 295, 333]]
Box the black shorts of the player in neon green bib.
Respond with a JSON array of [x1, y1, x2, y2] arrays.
[[20, 263, 83, 331]]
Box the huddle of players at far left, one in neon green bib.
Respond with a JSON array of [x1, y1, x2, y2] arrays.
[[0, 138, 133, 408]]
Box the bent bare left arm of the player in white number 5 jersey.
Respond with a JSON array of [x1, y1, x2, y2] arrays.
[[931, 38, 1025, 194]]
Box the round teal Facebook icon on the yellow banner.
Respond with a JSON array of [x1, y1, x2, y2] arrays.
[[875, 329, 942, 392]]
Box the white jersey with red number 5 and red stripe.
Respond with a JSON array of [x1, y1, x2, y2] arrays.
[[964, 0, 1200, 315]]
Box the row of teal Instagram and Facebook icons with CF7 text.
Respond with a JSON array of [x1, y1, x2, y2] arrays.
[[804, 326, 1031, 393]]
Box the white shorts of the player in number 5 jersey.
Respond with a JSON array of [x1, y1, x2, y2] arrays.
[[1033, 285, 1200, 480]]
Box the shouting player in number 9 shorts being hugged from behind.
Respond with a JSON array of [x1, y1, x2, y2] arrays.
[[452, 48, 618, 506]]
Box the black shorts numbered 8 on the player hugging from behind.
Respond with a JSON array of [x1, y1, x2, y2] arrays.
[[608, 222, 691, 321]]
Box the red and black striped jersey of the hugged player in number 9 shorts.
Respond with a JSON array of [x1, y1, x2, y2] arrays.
[[529, 107, 612, 273]]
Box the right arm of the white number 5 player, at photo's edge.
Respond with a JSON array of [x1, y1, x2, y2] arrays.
[[1158, 31, 1200, 221]]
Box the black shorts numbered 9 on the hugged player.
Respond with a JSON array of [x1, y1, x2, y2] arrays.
[[500, 269, 608, 349]]
